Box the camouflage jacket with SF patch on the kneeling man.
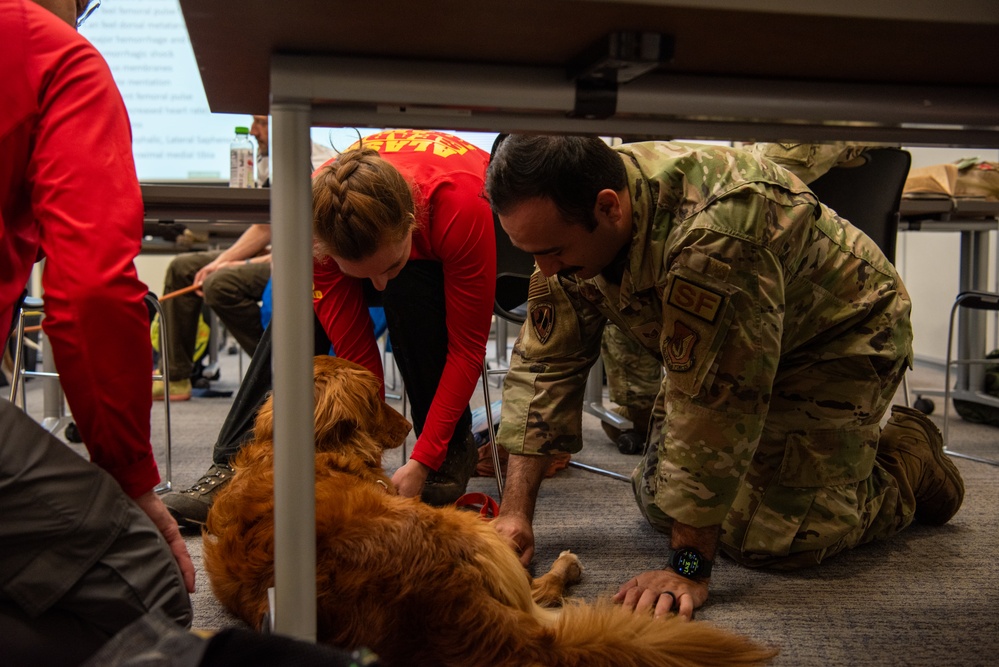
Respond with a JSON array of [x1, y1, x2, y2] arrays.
[[499, 142, 911, 525]]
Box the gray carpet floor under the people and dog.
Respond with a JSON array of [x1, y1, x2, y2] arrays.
[[17, 355, 999, 666]]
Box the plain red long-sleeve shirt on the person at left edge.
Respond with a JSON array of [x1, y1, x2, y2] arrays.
[[0, 0, 160, 497]]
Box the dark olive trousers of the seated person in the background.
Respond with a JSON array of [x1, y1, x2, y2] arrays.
[[163, 250, 271, 382]]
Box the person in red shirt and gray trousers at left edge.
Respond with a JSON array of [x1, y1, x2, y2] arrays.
[[0, 0, 194, 665]]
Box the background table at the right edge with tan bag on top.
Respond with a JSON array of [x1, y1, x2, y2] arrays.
[[899, 199, 999, 404]]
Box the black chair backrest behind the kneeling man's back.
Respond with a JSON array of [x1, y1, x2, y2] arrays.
[[808, 148, 911, 263]]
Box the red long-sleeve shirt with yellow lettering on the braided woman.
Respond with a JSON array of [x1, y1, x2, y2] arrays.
[[313, 130, 496, 470]]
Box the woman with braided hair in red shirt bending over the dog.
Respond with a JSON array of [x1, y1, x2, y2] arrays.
[[164, 130, 496, 524]]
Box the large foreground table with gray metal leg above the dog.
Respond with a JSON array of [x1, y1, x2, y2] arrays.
[[180, 0, 999, 639]]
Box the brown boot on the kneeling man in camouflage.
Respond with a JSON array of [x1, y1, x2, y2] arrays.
[[878, 405, 964, 526]]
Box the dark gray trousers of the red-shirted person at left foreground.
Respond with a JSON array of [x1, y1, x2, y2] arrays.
[[0, 400, 192, 667]]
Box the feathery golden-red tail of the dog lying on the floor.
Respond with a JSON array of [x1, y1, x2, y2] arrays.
[[538, 600, 777, 667]]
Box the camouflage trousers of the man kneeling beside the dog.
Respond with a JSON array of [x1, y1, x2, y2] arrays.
[[632, 358, 915, 569]]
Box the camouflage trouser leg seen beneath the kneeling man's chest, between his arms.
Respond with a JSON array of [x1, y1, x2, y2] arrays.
[[600, 323, 663, 418]]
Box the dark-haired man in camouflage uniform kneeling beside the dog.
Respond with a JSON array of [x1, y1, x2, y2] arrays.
[[486, 135, 964, 617]]
